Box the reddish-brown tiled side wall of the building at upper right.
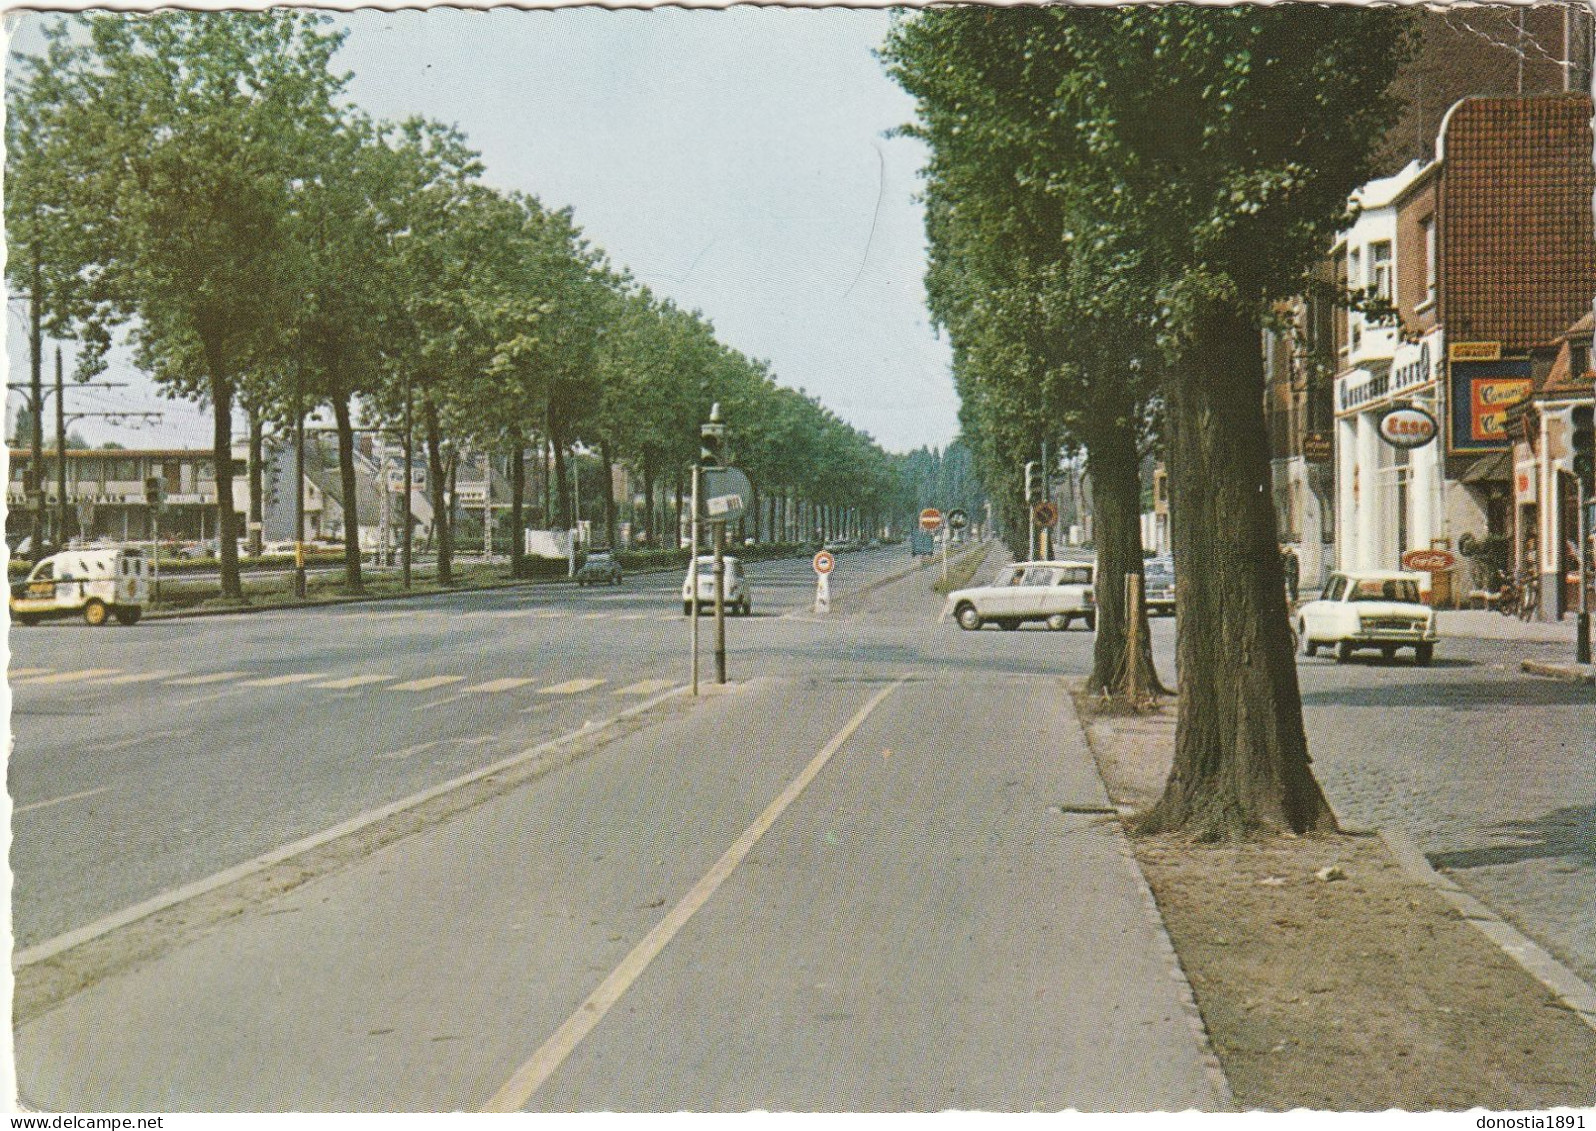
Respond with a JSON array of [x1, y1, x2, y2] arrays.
[[1440, 94, 1596, 351]]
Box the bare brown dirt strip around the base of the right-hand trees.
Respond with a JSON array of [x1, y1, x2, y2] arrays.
[[1076, 694, 1596, 1112]]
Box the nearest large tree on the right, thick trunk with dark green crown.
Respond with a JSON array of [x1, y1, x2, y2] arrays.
[[887, 6, 1408, 836]]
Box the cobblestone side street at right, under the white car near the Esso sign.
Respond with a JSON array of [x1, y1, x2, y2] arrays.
[[1154, 613, 1596, 984]]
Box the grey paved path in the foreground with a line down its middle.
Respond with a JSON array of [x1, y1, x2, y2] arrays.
[[16, 672, 1229, 1112]]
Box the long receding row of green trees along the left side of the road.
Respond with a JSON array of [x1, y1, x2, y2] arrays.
[[5, 10, 915, 597]]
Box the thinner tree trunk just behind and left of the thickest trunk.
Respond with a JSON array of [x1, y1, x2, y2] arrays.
[[1085, 416, 1167, 700]]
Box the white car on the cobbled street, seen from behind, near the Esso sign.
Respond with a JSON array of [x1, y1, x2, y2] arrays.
[[1296, 569, 1438, 667]]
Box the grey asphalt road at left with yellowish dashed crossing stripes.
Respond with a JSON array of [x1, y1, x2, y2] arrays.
[[10, 549, 938, 949]]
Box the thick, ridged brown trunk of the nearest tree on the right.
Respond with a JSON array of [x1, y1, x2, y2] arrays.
[[1142, 303, 1336, 839]]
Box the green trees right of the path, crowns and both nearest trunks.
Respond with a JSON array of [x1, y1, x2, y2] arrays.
[[883, 5, 1411, 836]]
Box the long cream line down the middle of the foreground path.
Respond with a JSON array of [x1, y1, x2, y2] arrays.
[[482, 676, 908, 1112]]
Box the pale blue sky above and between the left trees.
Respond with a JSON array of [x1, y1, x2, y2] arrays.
[[6, 8, 958, 451]]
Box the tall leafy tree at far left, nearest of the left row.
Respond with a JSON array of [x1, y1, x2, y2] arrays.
[[19, 10, 343, 598]]
